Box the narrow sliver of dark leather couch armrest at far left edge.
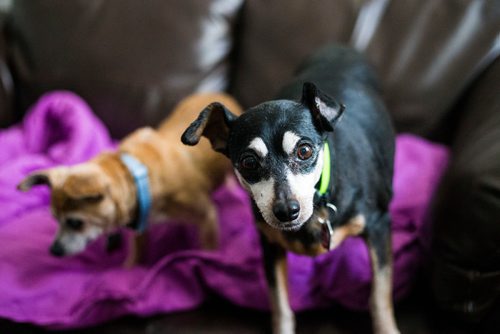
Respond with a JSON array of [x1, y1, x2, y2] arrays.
[[0, 11, 14, 128]]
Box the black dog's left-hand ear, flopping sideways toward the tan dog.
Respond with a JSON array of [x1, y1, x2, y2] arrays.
[[181, 102, 238, 155]]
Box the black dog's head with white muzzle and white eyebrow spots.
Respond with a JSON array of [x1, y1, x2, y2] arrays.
[[182, 83, 343, 230]]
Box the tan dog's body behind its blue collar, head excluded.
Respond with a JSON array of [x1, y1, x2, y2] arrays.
[[120, 94, 242, 249]]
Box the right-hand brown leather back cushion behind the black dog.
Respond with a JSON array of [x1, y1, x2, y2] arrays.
[[233, 0, 500, 138]]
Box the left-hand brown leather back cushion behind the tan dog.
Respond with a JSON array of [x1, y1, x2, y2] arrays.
[[9, 0, 241, 137]]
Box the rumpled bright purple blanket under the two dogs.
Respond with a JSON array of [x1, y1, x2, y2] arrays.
[[0, 92, 448, 328]]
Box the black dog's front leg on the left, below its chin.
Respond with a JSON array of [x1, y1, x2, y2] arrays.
[[260, 233, 295, 334]]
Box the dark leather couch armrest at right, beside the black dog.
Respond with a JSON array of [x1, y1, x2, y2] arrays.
[[432, 57, 500, 319]]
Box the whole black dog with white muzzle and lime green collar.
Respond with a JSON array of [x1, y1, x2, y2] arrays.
[[182, 46, 398, 334]]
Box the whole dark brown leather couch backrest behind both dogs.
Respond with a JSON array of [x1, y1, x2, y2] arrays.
[[4, 0, 500, 137]]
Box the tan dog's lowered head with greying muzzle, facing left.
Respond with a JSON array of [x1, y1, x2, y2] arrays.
[[18, 163, 117, 256]]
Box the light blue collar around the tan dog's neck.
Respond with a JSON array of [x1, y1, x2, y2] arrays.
[[120, 153, 151, 232]]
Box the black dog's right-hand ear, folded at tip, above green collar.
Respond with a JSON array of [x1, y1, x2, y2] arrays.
[[301, 82, 345, 131]]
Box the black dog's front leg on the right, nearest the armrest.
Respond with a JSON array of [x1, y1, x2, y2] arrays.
[[366, 214, 399, 334]]
